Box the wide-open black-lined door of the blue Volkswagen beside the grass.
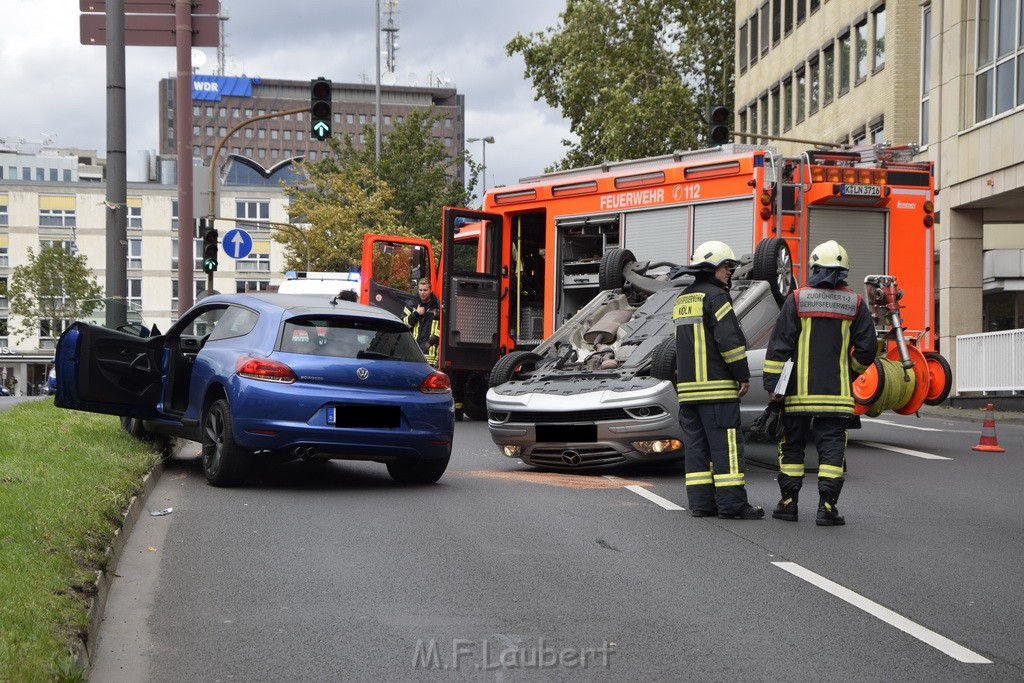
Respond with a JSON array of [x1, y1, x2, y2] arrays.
[[54, 321, 164, 420]]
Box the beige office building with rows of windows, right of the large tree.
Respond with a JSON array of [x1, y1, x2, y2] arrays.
[[734, 0, 1024, 389]]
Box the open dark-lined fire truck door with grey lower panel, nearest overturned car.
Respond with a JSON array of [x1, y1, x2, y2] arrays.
[[438, 207, 507, 372]]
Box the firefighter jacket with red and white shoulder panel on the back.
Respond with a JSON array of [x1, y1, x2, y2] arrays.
[[764, 286, 878, 416]]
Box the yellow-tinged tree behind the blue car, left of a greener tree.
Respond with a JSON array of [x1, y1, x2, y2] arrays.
[[274, 162, 412, 272]]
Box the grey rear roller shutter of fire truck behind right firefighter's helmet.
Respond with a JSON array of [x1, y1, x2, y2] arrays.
[[806, 207, 889, 293]]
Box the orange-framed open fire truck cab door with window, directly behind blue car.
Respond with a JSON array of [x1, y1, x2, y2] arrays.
[[359, 233, 437, 319]]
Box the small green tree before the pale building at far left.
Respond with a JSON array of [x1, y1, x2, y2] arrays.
[[7, 245, 103, 340]]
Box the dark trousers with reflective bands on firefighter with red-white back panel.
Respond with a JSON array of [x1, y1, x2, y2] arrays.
[[778, 413, 850, 502]]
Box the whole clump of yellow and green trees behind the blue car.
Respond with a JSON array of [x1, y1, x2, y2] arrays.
[[274, 111, 478, 270]]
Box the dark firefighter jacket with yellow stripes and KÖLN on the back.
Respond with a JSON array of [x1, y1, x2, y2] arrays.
[[672, 276, 751, 403]]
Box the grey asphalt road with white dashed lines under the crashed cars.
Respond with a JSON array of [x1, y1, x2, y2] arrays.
[[90, 415, 1024, 683]]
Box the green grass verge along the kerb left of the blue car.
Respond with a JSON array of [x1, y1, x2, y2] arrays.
[[0, 399, 160, 681]]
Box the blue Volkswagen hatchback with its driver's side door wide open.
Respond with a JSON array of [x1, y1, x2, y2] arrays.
[[54, 294, 455, 486]]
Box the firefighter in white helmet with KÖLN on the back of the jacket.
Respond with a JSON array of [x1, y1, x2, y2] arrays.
[[672, 241, 765, 519]]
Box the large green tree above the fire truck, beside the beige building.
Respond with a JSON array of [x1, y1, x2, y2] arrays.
[[506, 0, 735, 170]]
